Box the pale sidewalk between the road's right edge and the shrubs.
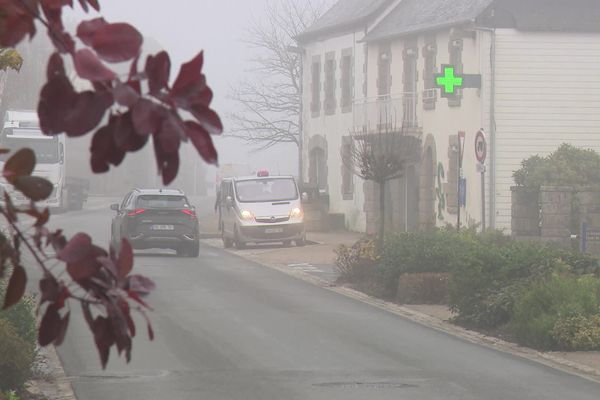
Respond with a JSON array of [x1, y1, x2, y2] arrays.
[[203, 231, 600, 381]]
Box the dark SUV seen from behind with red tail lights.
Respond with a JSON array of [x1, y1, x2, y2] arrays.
[[110, 189, 200, 257]]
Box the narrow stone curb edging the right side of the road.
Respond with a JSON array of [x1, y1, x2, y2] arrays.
[[204, 242, 600, 383]]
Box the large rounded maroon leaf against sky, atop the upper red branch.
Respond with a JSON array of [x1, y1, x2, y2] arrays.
[[92, 23, 144, 63]]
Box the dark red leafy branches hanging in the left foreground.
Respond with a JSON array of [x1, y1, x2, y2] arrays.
[[0, 0, 222, 367]]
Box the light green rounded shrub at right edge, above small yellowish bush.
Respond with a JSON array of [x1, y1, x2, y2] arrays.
[[508, 275, 600, 350]]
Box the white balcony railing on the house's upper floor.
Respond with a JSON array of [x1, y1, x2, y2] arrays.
[[354, 92, 419, 131]]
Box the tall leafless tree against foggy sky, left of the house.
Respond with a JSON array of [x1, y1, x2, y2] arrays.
[[227, 0, 330, 177]]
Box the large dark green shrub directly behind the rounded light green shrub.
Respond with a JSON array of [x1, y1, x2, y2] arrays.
[[449, 239, 598, 329]]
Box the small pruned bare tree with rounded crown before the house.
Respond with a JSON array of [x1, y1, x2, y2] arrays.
[[341, 123, 421, 249]]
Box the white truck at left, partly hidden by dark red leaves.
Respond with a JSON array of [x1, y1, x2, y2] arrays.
[[0, 110, 89, 211]]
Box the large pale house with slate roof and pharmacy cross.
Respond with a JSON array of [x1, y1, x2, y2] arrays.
[[298, 0, 600, 232]]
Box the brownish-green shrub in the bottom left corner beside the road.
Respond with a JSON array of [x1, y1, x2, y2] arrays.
[[0, 319, 35, 392]]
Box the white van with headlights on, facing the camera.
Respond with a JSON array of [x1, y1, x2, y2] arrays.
[[218, 171, 306, 249]]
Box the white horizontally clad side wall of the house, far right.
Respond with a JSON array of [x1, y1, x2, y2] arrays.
[[496, 29, 600, 229]]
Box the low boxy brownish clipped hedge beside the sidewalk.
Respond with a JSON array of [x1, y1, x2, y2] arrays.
[[396, 272, 450, 304]]
